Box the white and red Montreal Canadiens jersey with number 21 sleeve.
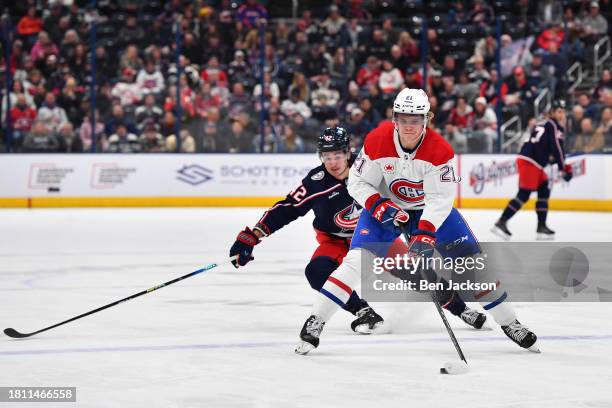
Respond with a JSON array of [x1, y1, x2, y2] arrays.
[[348, 122, 459, 231]]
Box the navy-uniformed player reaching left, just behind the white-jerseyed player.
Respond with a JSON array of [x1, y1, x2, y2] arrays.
[[230, 127, 383, 334]]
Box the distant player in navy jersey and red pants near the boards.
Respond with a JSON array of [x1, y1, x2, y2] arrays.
[[492, 100, 572, 240]]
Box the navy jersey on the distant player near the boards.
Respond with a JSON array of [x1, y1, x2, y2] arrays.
[[519, 119, 565, 169]]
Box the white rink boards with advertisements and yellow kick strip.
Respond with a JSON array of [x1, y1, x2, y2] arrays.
[[0, 154, 612, 211]]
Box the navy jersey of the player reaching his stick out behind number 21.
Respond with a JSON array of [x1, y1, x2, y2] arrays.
[[256, 157, 361, 238]]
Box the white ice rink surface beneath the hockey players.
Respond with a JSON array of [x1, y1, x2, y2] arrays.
[[0, 209, 612, 408]]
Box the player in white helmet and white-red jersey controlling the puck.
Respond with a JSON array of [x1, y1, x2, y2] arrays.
[[295, 88, 539, 354]]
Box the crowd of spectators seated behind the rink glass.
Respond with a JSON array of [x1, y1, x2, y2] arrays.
[[0, 0, 612, 153]]
